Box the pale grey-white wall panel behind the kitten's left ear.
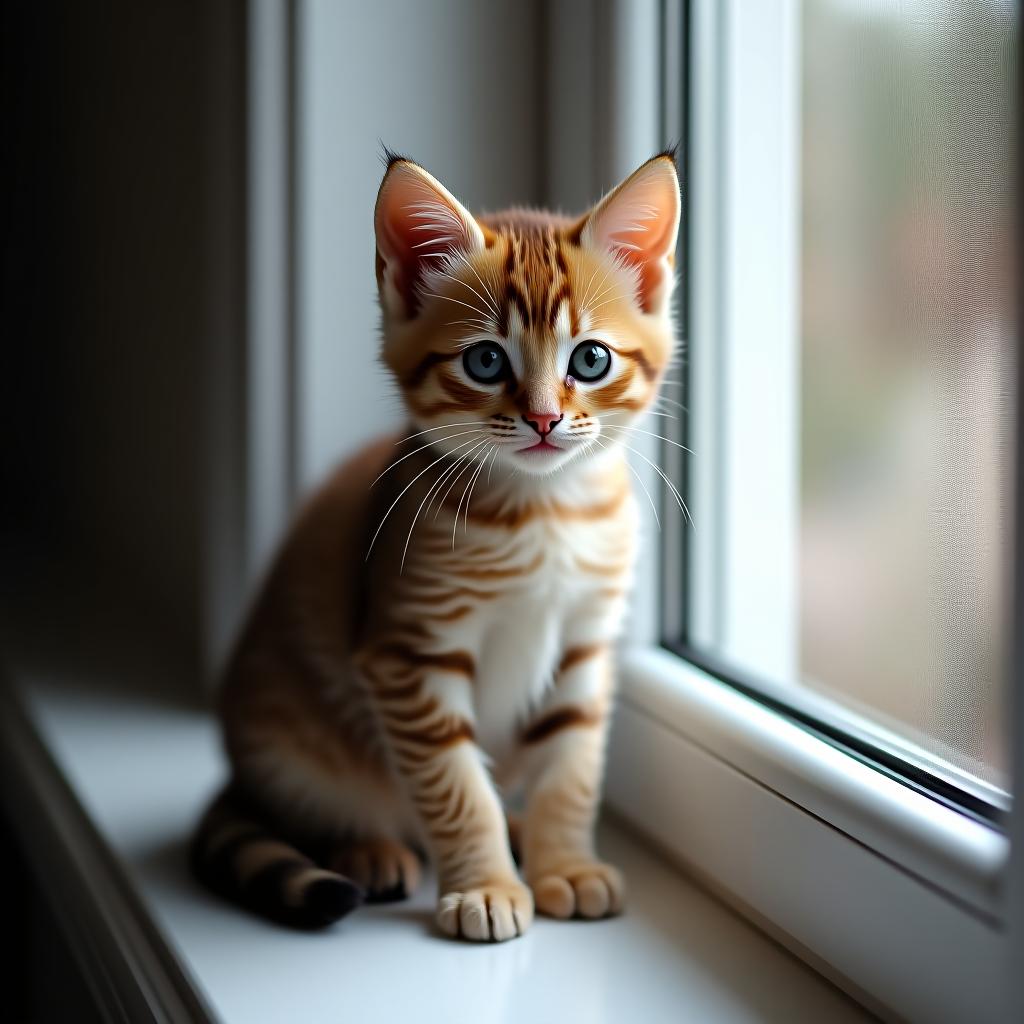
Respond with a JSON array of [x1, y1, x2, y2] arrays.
[[296, 0, 544, 488]]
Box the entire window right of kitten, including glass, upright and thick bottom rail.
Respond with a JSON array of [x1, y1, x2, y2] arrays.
[[608, 0, 1020, 1021]]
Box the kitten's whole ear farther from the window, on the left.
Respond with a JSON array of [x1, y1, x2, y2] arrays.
[[374, 158, 485, 317]]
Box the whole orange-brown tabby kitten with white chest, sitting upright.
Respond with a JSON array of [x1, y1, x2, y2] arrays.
[[194, 154, 680, 941]]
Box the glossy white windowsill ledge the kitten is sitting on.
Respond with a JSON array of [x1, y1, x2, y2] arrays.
[[0, 577, 868, 1022]]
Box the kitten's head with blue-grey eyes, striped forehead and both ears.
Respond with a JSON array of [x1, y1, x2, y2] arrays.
[[374, 154, 680, 474]]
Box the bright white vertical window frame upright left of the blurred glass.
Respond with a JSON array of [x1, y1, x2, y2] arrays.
[[688, 0, 800, 679]]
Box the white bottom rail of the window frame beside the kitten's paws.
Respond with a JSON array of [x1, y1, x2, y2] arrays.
[[606, 649, 1008, 1024]]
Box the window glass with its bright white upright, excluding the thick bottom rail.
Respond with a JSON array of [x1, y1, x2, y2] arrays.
[[666, 0, 1016, 815]]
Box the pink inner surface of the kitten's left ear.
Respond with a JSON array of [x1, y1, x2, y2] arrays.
[[376, 165, 471, 316]]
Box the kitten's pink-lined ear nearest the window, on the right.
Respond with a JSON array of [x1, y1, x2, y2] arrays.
[[580, 153, 680, 313]]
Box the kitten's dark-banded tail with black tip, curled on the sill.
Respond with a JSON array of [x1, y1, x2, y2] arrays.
[[190, 788, 364, 929]]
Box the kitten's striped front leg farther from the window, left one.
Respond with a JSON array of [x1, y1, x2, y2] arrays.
[[364, 646, 534, 941]]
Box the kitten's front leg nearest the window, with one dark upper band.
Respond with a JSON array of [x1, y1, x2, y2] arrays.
[[522, 646, 625, 918]]
